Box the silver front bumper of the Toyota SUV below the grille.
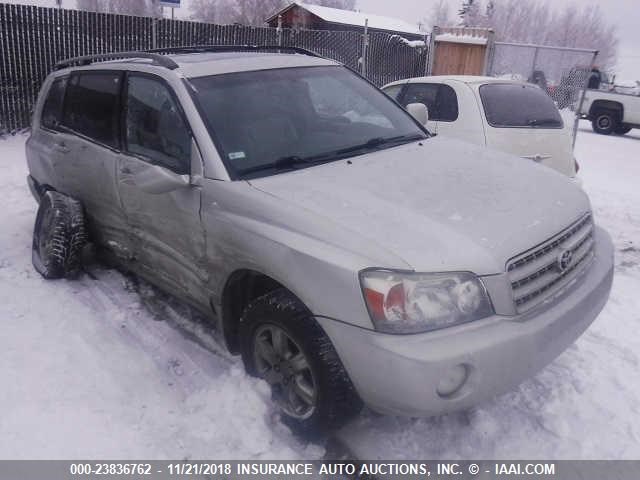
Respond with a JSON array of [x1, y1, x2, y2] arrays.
[[317, 228, 613, 416]]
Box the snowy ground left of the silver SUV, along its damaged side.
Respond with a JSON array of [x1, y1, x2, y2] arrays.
[[0, 136, 324, 459]]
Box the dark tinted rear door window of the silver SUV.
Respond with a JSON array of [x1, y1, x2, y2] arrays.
[[63, 72, 121, 148]]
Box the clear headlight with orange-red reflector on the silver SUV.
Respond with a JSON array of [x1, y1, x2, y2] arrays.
[[360, 270, 494, 333]]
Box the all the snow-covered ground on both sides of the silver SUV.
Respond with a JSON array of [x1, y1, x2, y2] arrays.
[[0, 123, 640, 459]]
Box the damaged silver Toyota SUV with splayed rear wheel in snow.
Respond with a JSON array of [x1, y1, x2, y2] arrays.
[[27, 47, 613, 430]]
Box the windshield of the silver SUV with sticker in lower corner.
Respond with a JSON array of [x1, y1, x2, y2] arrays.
[[190, 66, 427, 178]]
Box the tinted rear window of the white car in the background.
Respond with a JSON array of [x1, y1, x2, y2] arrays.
[[480, 83, 564, 128]]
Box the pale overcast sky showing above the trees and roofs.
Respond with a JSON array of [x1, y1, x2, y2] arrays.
[[5, 0, 640, 81]]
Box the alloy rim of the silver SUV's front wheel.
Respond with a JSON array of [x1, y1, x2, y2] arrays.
[[253, 324, 318, 420]]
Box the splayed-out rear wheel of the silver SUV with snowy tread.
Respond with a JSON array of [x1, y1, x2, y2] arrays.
[[31, 191, 87, 279]]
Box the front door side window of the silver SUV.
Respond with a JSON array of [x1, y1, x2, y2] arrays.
[[125, 75, 191, 175]]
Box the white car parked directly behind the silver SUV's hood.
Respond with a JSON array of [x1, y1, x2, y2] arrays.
[[382, 75, 578, 178]]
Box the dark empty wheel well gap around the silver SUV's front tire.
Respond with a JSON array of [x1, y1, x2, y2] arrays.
[[222, 270, 284, 353]]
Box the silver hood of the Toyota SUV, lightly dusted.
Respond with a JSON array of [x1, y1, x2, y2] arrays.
[[250, 137, 590, 275]]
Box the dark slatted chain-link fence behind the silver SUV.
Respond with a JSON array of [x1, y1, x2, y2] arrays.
[[0, 3, 428, 133]]
